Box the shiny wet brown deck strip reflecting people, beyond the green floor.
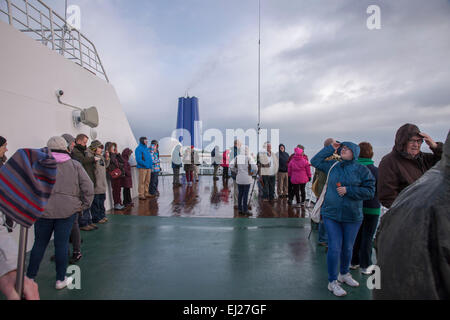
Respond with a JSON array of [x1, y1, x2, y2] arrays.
[[110, 176, 311, 218]]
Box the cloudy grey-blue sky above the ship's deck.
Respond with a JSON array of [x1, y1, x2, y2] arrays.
[[47, 0, 450, 164]]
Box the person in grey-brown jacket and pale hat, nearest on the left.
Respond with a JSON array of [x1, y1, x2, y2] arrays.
[[27, 137, 94, 289]]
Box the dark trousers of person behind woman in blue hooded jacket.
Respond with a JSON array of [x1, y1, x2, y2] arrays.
[[352, 214, 380, 269]]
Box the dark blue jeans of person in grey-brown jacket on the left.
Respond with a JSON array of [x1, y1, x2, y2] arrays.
[[27, 214, 78, 281]]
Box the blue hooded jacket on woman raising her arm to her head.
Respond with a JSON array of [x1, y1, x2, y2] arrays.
[[311, 142, 375, 222]]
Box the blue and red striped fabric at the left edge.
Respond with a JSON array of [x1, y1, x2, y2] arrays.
[[0, 148, 57, 228]]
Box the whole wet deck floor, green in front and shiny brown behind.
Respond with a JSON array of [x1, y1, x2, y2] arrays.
[[29, 177, 371, 300]]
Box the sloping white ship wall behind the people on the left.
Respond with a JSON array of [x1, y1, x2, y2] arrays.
[[0, 21, 138, 218]]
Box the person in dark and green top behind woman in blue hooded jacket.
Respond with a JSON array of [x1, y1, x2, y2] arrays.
[[350, 142, 381, 275]]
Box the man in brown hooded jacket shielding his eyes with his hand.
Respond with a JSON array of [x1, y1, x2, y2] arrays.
[[377, 123, 443, 208]]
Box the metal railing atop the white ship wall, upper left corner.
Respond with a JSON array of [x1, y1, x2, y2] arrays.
[[0, 0, 109, 82]]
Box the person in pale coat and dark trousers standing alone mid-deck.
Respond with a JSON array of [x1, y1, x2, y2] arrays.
[[230, 147, 258, 216]]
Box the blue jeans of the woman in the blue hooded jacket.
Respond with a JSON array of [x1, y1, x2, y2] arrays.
[[323, 217, 362, 282]]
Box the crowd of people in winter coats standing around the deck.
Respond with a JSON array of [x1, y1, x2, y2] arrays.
[[0, 124, 443, 297]]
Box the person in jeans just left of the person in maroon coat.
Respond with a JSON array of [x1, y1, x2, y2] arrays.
[[89, 140, 111, 224]]
